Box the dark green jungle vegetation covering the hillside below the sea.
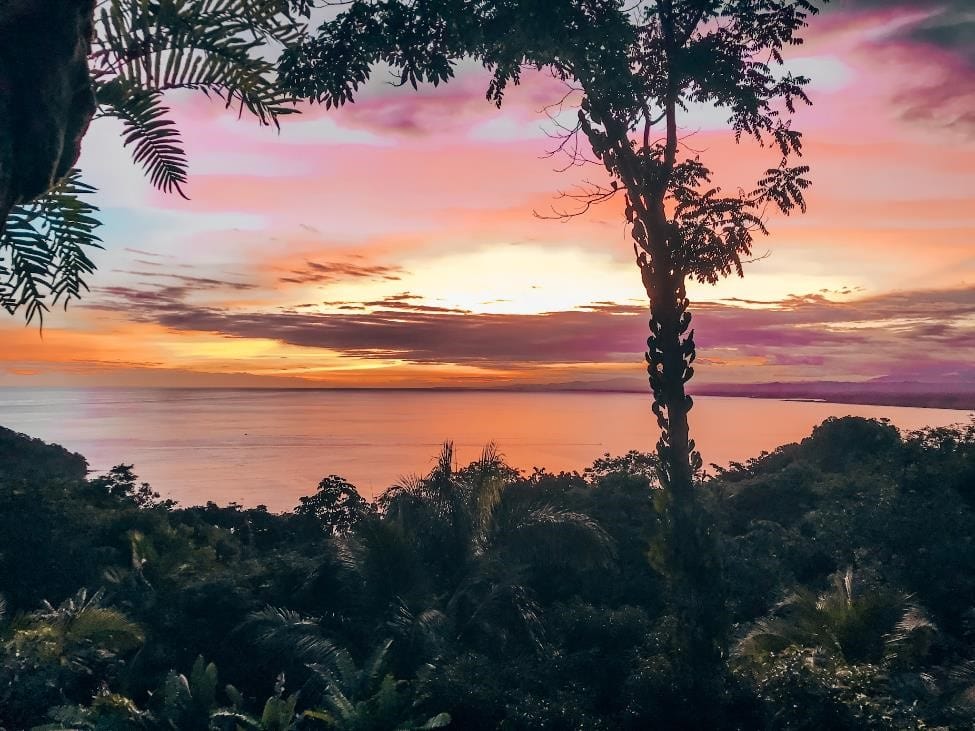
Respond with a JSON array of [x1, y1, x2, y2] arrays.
[[0, 418, 975, 729]]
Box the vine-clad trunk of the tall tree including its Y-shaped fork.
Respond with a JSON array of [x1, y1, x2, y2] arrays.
[[580, 66, 724, 708]]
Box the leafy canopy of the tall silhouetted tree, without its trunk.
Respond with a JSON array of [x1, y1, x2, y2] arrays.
[[281, 0, 817, 282]]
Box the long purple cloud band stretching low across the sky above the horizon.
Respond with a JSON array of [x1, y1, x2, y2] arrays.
[[89, 286, 975, 384]]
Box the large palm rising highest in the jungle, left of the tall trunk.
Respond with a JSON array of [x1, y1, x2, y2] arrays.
[[376, 442, 614, 649]]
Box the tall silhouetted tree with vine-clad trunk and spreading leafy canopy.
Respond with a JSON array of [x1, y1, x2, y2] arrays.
[[281, 0, 832, 692]]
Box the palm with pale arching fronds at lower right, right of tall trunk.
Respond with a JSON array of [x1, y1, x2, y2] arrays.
[[734, 569, 936, 729]]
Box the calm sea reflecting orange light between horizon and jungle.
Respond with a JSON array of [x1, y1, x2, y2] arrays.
[[0, 389, 971, 510]]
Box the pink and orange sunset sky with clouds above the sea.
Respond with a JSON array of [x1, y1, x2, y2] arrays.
[[0, 0, 975, 388]]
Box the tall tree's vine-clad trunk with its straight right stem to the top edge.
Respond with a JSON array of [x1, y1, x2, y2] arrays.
[[634, 10, 724, 696]]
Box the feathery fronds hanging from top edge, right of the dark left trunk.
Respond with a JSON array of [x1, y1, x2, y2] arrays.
[[92, 0, 299, 197]]
